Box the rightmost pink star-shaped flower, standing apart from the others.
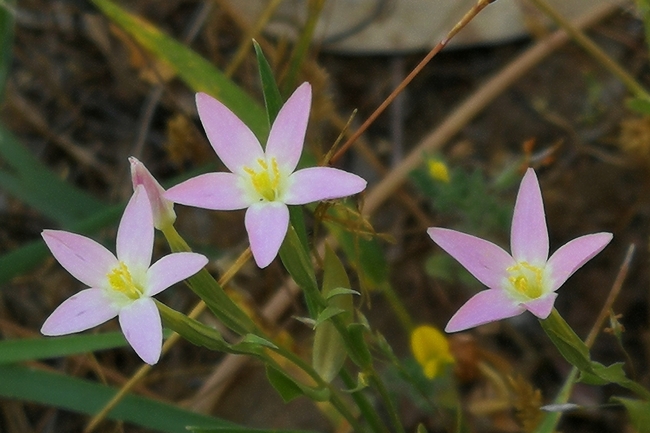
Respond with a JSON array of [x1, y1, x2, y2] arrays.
[[427, 168, 612, 332]]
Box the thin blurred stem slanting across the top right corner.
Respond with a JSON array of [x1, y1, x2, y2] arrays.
[[531, 0, 650, 100]]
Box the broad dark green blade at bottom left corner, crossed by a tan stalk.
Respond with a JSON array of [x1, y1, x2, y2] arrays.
[[0, 364, 236, 433]]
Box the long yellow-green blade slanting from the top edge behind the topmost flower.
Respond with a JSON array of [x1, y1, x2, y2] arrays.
[[93, 0, 269, 142]]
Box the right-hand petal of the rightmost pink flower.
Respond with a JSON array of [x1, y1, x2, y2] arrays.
[[546, 233, 612, 290]]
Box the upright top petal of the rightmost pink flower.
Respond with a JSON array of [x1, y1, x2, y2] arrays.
[[510, 168, 548, 266]]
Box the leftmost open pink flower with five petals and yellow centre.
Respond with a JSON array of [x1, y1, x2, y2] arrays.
[[41, 186, 208, 364]]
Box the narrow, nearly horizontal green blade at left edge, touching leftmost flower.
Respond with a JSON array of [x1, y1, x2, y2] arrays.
[[0, 332, 127, 364]]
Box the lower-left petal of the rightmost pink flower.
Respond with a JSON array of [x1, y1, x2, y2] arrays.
[[445, 289, 525, 332]]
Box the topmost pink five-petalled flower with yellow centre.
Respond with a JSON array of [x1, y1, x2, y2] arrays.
[[165, 83, 366, 268]]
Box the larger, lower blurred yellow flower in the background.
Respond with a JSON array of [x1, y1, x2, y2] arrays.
[[411, 325, 454, 379]]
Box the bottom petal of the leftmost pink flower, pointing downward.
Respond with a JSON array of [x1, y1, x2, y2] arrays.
[[119, 297, 162, 365]]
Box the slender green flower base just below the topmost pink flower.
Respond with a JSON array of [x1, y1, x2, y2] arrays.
[[280, 225, 325, 317]]
